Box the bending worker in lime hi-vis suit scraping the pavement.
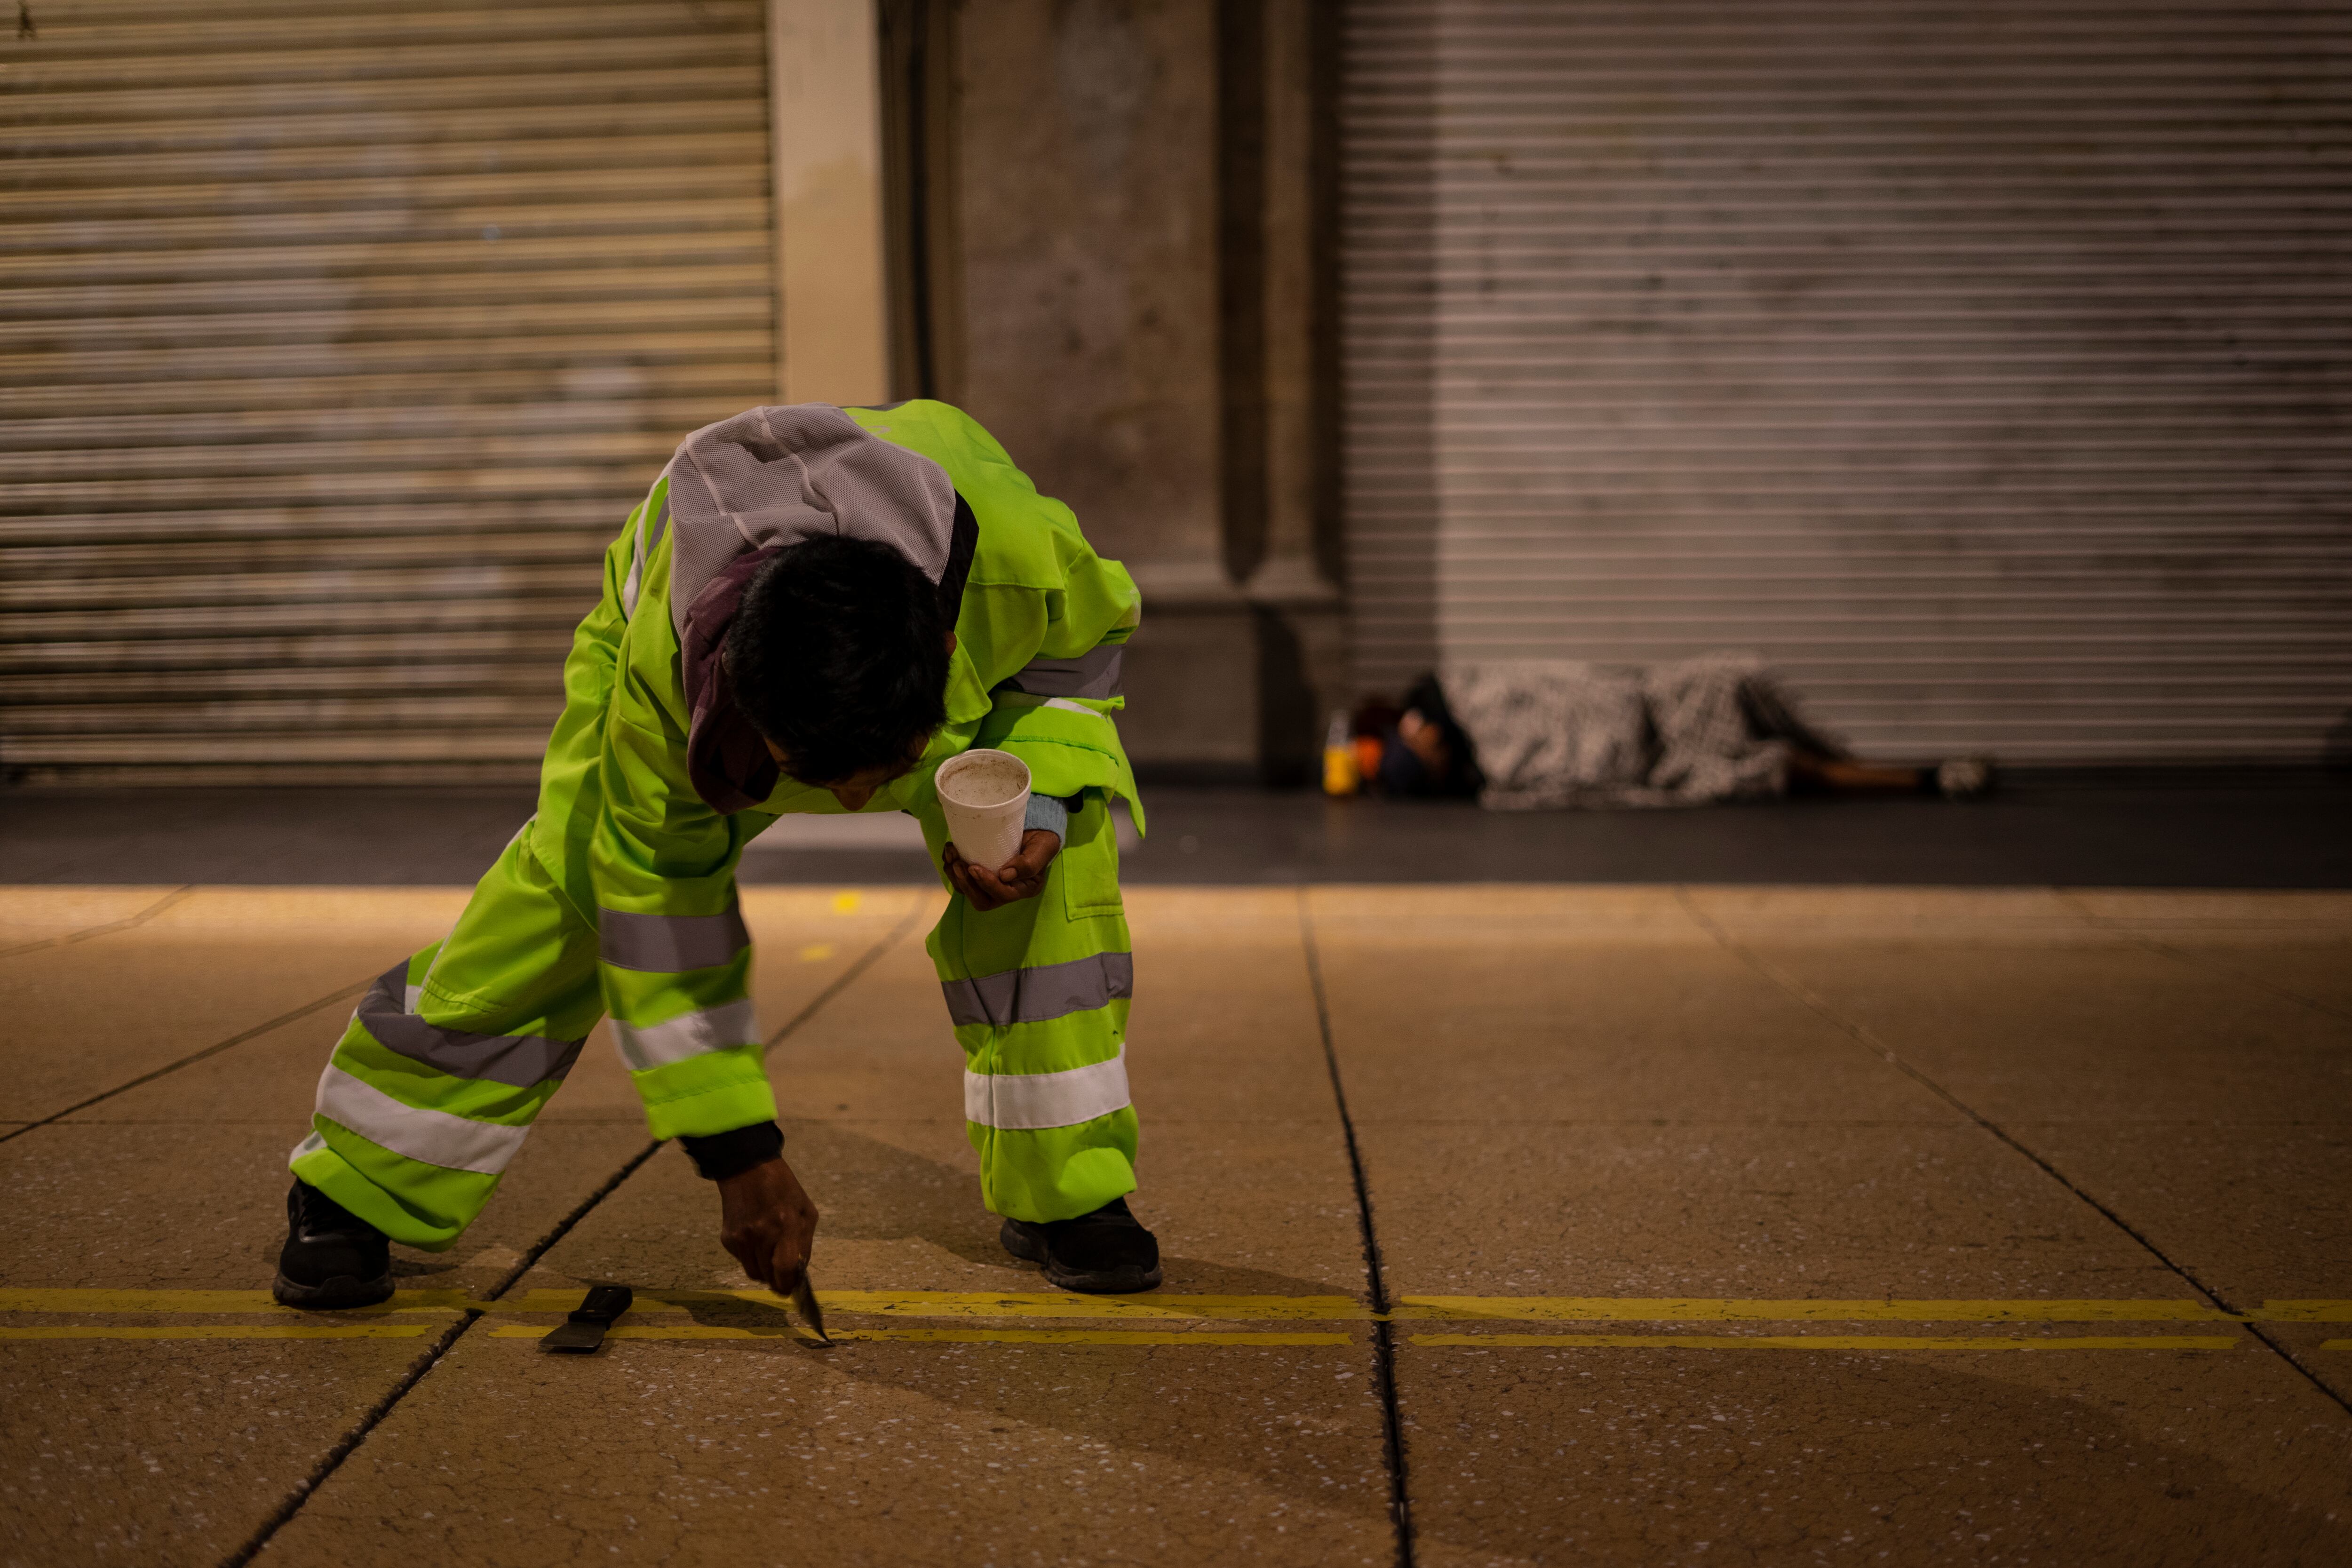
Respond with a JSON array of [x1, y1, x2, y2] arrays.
[[275, 402, 1160, 1307]]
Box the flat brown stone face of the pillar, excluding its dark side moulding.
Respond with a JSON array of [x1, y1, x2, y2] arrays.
[[957, 0, 1218, 588]]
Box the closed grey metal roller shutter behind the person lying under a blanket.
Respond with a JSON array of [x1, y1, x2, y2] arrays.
[[1343, 0, 2352, 762]]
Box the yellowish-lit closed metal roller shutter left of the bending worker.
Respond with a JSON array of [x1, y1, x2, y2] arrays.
[[0, 0, 776, 780]]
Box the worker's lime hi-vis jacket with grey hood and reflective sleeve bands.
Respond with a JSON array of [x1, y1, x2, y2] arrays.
[[527, 399, 1143, 1138]]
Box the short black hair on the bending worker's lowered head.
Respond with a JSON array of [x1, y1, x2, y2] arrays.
[[727, 533, 953, 785]]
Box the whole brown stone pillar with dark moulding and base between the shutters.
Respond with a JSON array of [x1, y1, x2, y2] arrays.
[[908, 0, 1338, 778]]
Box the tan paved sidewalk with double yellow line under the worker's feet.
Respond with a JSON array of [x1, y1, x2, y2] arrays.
[[0, 884, 2352, 1568]]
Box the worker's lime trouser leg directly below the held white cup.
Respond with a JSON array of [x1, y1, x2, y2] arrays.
[[927, 799, 1136, 1220]]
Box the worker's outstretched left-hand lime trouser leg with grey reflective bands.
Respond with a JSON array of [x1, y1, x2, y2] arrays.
[[289, 837, 602, 1250]]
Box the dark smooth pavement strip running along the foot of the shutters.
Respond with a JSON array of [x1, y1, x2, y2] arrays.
[[14, 769, 2352, 889]]
